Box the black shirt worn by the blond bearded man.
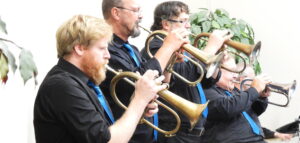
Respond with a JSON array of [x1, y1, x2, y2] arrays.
[[34, 59, 110, 143]]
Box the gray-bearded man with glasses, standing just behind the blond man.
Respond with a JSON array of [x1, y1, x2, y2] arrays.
[[100, 0, 188, 143]]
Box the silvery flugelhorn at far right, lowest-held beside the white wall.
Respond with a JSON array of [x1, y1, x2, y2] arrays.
[[240, 79, 297, 107]]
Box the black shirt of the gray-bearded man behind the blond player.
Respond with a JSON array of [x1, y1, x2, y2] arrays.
[[100, 35, 161, 143]]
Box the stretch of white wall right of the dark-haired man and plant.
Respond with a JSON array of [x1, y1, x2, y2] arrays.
[[187, 0, 300, 133]]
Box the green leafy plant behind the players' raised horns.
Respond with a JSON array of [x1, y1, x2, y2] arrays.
[[190, 8, 261, 74]]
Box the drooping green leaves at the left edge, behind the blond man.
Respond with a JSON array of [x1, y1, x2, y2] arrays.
[[0, 17, 38, 85]]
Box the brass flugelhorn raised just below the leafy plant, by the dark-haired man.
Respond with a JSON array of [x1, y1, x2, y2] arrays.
[[193, 32, 261, 73]]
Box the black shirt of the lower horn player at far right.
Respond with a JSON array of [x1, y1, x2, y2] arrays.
[[202, 85, 268, 143]]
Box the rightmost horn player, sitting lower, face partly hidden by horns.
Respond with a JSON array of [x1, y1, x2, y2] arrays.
[[202, 55, 270, 143]]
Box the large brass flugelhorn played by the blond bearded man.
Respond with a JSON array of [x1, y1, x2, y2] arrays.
[[106, 65, 208, 137]]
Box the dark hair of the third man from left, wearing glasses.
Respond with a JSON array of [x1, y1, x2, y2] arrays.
[[151, 1, 189, 31]]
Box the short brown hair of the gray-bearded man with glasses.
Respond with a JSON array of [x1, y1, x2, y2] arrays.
[[102, 0, 123, 20]]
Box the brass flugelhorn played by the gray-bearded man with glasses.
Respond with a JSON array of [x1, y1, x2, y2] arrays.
[[140, 26, 224, 86]]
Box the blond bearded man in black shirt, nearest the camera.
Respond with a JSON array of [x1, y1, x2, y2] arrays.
[[34, 15, 165, 143]]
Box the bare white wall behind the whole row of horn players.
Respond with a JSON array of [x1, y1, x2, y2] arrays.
[[0, 0, 300, 143]]
